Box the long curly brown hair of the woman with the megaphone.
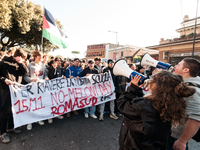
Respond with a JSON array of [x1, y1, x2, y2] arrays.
[[147, 71, 195, 125]]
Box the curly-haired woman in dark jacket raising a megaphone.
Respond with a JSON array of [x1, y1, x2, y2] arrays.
[[117, 71, 195, 150]]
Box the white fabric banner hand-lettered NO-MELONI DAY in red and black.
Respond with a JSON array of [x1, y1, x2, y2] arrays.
[[9, 73, 115, 128]]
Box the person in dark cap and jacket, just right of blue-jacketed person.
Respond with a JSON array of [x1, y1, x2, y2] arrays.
[[81, 60, 99, 119]]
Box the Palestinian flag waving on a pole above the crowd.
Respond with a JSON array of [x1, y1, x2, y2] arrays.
[[42, 9, 68, 48]]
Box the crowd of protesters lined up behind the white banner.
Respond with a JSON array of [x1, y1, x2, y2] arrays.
[[0, 49, 130, 143]]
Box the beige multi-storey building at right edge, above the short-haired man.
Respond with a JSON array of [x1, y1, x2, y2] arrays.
[[146, 15, 200, 65]]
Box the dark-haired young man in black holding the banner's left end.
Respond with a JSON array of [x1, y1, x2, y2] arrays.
[[0, 49, 28, 143]]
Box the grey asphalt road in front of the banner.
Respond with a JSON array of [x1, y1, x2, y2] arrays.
[[0, 110, 200, 150]]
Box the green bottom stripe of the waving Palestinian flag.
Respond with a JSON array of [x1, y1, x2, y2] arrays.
[[42, 29, 68, 48]]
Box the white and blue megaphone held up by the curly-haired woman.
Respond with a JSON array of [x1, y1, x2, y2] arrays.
[[113, 58, 147, 84]]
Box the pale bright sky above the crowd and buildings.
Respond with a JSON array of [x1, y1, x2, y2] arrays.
[[31, 0, 200, 57]]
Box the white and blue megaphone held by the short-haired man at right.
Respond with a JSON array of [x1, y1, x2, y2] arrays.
[[140, 53, 174, 72]]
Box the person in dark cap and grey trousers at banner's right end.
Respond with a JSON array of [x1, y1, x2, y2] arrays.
[[99, 59, 118, 121]]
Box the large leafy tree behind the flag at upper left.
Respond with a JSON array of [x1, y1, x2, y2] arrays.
[[0, 0, 62, 51]]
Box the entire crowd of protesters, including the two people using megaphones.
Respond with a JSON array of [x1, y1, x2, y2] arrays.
[[0, 49, 200, 150]]
